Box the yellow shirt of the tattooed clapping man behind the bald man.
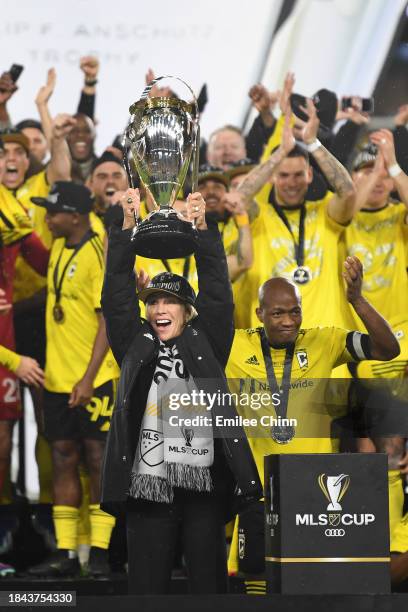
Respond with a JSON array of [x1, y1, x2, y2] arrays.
[[234, 192, 354, 327]]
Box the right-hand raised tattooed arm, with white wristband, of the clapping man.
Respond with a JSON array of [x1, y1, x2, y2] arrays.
[[297, 99, 355, 225]]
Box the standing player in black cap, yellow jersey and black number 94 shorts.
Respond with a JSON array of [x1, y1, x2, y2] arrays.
[[26, 181, 118, 576]]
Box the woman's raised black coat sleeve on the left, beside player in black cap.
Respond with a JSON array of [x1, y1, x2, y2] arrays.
[[101, 225, 142, 365]]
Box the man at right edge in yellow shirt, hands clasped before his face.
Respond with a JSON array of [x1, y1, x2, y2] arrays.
[[345, 130, 408, 548]]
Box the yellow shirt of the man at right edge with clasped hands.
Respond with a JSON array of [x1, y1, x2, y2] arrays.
[[345, 203, 408, 331]]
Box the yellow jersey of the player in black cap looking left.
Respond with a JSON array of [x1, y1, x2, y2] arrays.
[[45, 232, 119, 393]]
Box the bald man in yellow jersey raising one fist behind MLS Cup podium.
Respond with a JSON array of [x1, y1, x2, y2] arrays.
[[226, 257, 399, 586]]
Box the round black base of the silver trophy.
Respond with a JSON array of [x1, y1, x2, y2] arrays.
[[132, 209, 198, 259]]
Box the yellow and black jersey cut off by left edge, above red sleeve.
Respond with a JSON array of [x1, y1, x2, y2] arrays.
[[0, 185, 33, 246]]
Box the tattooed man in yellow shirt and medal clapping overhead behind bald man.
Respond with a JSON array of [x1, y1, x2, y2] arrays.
[[236, 107, 355, 327]]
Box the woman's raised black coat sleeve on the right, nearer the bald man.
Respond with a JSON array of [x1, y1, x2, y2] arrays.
[[195, 224, 234, 367]]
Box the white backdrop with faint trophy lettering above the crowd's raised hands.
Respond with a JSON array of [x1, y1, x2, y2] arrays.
[[0, 0, 281, 152]]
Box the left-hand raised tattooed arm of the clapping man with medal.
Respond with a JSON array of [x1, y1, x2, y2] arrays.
[[237, 108, 295, 222]]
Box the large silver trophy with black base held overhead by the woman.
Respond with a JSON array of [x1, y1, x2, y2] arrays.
[[126, 76, 199, 259]]
